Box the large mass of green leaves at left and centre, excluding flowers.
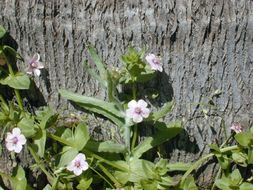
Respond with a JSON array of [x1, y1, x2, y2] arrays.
[[0, 27, 188, 190]]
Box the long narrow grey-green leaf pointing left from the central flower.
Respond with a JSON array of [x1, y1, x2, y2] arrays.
[[59, 90, 124, 127]]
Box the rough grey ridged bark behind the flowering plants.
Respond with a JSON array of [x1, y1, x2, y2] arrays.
[[0, 0, 253, 188]]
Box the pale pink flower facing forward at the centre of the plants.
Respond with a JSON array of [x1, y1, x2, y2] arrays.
[[126, 99, 150, 123]]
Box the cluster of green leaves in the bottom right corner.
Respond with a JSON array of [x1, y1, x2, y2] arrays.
[[210, 128, 253, 190]]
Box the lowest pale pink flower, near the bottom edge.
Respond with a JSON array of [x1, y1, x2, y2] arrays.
[[67, 153, 89, 176]]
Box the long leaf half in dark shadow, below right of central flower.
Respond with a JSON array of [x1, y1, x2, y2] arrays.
[[133, 121, 182, 158]]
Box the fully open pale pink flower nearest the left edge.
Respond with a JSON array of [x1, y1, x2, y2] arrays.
[[5, 128, 26, 153]]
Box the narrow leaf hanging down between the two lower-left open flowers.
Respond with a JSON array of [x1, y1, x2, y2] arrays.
[[33, 130, 47, 158]]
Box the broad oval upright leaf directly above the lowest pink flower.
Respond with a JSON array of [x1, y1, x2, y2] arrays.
[[73, 123, 90, 151]]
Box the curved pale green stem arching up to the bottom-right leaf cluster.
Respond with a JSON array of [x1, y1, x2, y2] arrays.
[[181, 145, 238, 183]]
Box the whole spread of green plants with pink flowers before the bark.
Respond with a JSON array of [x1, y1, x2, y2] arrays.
[[0, 26, 253, 190]]
